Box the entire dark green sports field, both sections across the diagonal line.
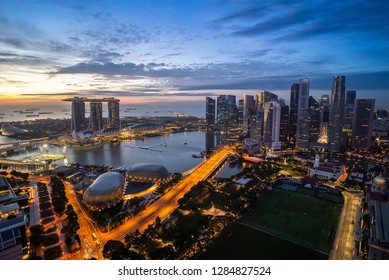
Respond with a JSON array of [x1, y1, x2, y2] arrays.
[[199, 189, 342, 260]]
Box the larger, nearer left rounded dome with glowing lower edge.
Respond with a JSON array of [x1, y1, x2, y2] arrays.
[[83, 172, 126, 209]]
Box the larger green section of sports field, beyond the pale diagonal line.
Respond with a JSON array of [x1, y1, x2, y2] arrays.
[[241, 189, 342, 253]]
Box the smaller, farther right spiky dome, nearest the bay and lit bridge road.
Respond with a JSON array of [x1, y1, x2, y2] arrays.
[[127, 163, 170, 183]]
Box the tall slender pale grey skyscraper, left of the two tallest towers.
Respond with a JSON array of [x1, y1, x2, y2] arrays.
[[296, 77, 310, 149]]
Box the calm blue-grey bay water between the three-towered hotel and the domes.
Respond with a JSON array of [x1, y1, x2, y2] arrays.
[[6, 131, 205, 173]]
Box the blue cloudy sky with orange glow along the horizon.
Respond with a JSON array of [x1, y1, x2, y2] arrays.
[[0, 0, 389, 108]]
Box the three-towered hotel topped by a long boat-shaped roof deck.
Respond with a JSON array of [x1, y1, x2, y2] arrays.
[[62, 97, 120, 132]]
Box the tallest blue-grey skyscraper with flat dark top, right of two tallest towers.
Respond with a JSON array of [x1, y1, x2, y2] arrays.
[[329, 76, 346, 151]]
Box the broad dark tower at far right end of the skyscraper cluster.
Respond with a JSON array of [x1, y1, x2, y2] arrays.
[[352, 99, 375, 150]]
